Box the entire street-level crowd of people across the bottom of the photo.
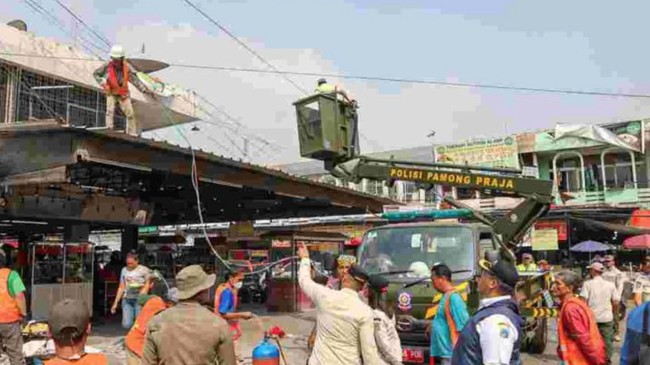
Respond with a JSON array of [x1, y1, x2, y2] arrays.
[[0, 245, 650, 365]]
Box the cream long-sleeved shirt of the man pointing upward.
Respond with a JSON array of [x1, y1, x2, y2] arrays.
[[298, 259, 380, 365]]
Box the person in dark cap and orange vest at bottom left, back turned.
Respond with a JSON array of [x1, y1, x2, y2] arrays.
[[44, 299, 108, 365]]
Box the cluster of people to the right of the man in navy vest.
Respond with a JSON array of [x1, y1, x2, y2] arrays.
[[517, 253, 650, 365]]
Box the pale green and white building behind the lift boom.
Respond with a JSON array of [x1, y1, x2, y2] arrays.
[[277, 120, 650, 211]]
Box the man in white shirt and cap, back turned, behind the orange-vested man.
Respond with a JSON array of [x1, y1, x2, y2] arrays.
[[580, 262, 621, 364]]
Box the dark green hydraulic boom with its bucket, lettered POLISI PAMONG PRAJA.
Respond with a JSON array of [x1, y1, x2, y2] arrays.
[[294, 94, 553, 260]]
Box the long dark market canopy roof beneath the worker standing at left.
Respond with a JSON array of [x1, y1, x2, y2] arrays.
[[0, 125, 395, 230]]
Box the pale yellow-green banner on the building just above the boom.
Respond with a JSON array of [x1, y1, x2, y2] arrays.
[[435, 136, 519, 169]]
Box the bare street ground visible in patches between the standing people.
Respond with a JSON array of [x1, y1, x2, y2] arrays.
[[83, 302, 625, 365]]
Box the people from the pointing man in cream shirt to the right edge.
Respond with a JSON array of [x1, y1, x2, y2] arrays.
[[298, 247, 650, 365]]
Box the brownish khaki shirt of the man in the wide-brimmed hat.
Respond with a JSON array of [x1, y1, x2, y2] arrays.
[[141, 302, 237, 365]]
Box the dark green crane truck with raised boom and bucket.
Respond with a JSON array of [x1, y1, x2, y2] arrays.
[[294, 90, 557, 364]]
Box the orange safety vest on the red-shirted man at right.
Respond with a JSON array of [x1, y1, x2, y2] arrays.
[[557, 297, 605, 365]]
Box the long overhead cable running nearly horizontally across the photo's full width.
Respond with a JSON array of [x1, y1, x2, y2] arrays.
[[0, 52, 650, 99]]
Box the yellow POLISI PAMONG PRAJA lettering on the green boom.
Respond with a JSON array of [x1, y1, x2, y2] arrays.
[[389, 167, 516, 191]]
